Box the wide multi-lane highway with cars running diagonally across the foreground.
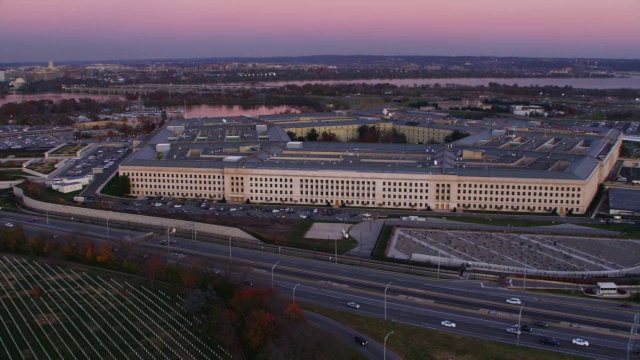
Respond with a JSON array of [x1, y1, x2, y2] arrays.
[[0, 212, 638, 359]]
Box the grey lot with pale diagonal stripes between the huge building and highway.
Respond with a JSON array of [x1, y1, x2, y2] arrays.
[[388, 228, 640, 271]]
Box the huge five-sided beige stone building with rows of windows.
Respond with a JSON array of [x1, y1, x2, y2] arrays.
[[119, 114, 622, 214]]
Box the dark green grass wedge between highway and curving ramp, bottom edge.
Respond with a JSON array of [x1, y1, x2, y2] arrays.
[[305, 306, 584, 360]]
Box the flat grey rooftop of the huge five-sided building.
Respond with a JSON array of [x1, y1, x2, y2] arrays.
[[123, 114, 619, 180]]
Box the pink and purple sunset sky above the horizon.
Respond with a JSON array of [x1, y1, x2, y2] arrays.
[[0, 0, 640, 62]]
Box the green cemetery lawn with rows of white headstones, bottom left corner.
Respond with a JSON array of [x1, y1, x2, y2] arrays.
[[0, 257, 231, 359]]
